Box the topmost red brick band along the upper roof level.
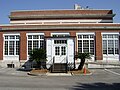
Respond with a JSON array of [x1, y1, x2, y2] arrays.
[[11, 10, 112, 16]]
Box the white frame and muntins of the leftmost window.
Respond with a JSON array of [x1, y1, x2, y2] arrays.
[[3, 33, 20, 56]]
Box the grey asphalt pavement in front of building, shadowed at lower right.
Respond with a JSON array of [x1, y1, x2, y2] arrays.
[[0, 68, 120, 90]]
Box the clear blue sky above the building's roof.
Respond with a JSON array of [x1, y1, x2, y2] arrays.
[[0, 0, 120, 24]]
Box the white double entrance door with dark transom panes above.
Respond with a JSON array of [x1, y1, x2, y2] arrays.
[[54, 40, 67, 63]]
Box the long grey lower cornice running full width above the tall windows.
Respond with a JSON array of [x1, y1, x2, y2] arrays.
[[1, 26, 120, 31]]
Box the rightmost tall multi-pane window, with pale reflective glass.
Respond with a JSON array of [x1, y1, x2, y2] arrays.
[[102, 34, 119, 55]]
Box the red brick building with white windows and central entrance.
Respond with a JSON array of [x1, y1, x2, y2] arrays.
[[0, 9, 120, 67]]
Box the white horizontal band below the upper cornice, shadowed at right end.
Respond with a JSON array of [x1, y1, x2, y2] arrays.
[[10, 19, 113, 24]]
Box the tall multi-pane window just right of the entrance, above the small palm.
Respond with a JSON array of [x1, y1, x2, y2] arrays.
[[78, 34, 94, 55]]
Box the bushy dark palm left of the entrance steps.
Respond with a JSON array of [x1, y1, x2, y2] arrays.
[[30, 48, 47, 69]]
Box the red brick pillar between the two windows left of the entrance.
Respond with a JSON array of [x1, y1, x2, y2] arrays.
[[20, 32, 27, 60]]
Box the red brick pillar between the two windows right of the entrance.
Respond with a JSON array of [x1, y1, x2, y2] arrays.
[[95, 32, 103, 60]]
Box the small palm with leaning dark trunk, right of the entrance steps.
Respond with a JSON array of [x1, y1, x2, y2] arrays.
[[76, 53, 90, 70]]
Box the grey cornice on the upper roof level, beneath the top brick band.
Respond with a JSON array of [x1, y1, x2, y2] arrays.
[[9, 14, 115, 19]]
